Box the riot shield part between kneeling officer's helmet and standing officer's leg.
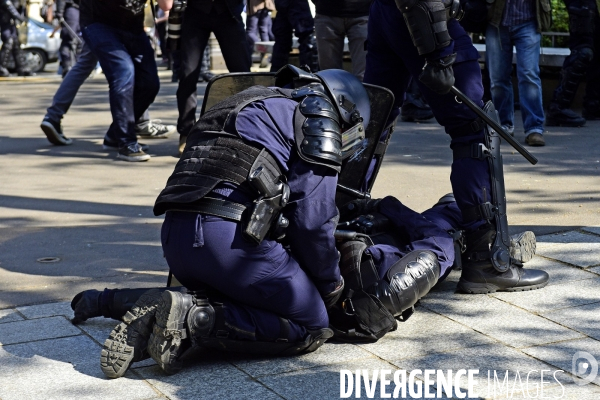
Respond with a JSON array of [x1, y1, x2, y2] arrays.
[[335, 83, 394, 208]]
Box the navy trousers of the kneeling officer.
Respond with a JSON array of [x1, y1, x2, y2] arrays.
[[161, 211, 329, 341]]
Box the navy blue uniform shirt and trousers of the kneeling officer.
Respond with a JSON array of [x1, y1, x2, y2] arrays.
[[162, 98, 340, 342]]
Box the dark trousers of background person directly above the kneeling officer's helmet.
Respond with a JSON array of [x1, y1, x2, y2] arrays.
[[271, 0, 315, 72]]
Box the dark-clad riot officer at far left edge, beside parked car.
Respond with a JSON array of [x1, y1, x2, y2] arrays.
[[0, 0, 32, 76]]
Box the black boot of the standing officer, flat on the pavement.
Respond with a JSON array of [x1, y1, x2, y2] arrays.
[[457, 224, 550, 294]]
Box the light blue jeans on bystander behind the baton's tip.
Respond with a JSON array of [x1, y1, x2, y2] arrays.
[[485, 21, 544, 135]]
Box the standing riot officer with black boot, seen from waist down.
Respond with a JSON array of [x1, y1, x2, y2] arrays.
[[364, 0, 549, 293]]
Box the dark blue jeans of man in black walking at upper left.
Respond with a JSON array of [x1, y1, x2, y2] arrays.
[[83, 23, 160, 149]]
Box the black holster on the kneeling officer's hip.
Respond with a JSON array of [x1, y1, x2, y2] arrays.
[[242, 149, 290, 244]]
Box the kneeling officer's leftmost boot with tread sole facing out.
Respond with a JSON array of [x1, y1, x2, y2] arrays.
[[100, 289, 162, 378]]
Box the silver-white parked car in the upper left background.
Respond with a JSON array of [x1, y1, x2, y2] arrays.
[[0, 18, 60, 72]]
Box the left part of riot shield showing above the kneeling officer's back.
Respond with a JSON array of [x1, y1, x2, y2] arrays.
[[200, 72, 275, 115]]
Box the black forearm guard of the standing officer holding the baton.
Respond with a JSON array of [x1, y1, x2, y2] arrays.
[[396, 0, 452, 56]]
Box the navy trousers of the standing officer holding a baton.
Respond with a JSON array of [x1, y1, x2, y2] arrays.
[[364, 0, 491, 229]]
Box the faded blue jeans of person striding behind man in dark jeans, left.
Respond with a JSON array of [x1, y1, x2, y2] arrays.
[[46, 43, 150, 134]]
